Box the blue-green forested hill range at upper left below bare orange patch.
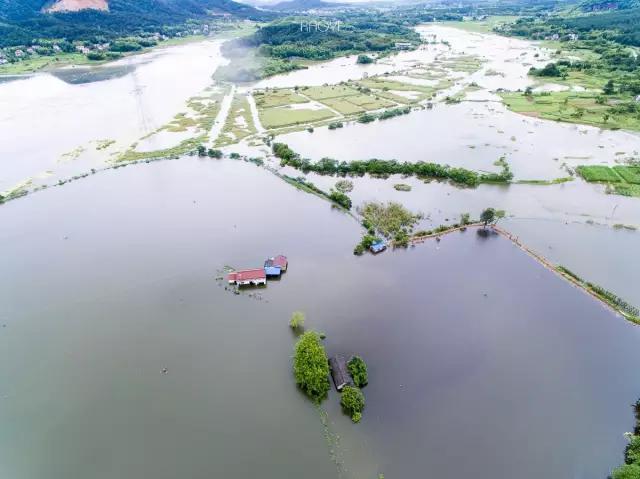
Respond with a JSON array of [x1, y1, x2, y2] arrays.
[[0, 0, 273, 47]]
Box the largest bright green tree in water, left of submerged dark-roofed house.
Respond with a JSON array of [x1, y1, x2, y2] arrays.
[[293, 331, 329, 402]]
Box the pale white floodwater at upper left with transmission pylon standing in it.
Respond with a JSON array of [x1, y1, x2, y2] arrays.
[[0, 40, 225, 191]]
